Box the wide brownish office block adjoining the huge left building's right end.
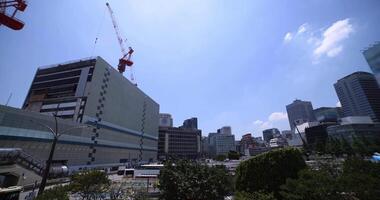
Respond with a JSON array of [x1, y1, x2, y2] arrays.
[[158, 118, 202, 160]]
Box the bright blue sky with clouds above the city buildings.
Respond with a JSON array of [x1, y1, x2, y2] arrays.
[[0, 0, 380, 139]]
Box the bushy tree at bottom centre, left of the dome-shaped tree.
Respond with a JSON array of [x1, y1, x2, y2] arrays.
[[158, 161, 232, 200]]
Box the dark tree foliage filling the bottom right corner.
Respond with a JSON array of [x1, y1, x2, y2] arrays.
[[280, 158, 380, 200]]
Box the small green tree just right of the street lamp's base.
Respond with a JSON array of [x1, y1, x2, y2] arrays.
[[70, 170, 111, 200]]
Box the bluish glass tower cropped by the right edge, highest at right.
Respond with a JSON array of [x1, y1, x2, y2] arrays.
[[363, 42, 380, 85]]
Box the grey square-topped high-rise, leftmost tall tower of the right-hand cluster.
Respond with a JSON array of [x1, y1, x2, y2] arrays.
[[286, 99, 315, 131]]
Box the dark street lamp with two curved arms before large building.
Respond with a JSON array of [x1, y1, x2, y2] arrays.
[[30, 104, 89, 196]]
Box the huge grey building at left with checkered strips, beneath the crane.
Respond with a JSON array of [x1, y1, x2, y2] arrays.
[[0, 57, 159, 166]]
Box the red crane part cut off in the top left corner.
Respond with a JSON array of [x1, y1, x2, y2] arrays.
[[0, 0, 27, 30]]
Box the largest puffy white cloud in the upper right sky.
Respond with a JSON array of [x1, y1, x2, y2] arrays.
[[313, 18, 354, 58]]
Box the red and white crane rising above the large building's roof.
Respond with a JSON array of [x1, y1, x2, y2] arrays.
[[106, 3, 134, 82]]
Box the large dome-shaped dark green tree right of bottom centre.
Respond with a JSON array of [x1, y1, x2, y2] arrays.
[[236, 148, 306, 197]]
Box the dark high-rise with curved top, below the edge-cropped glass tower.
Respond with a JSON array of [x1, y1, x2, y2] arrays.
[[334, 72, 380, 122]]
